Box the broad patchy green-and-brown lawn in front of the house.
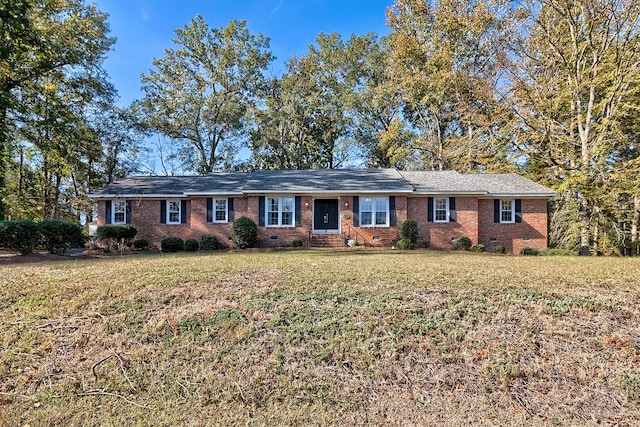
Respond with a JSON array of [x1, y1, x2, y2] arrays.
[[0, 251, 640, 426]]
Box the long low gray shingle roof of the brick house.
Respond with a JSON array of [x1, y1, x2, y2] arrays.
[[90, 169, 555, 199]]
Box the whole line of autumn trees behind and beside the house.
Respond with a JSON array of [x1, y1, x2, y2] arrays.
[[0, 0, 640, 254]]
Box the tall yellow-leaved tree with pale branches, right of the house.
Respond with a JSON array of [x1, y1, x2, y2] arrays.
[[510, 0, 640, 255]]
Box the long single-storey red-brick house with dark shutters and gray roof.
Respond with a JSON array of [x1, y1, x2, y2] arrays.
[[91, 169, 555, 253]]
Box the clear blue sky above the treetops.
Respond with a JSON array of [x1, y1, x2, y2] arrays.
[[93, 0, 393, 105]]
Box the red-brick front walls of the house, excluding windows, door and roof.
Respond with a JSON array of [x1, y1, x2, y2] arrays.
[[97, 195, 547, 253]]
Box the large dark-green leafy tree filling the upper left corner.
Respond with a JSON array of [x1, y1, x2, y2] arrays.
[[0, 0, 114, 219]]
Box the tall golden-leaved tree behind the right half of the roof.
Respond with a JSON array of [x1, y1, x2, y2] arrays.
[[387, 0, 507, 171]]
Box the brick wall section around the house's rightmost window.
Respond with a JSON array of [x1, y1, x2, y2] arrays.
[[478, 199, 547, 254]]
